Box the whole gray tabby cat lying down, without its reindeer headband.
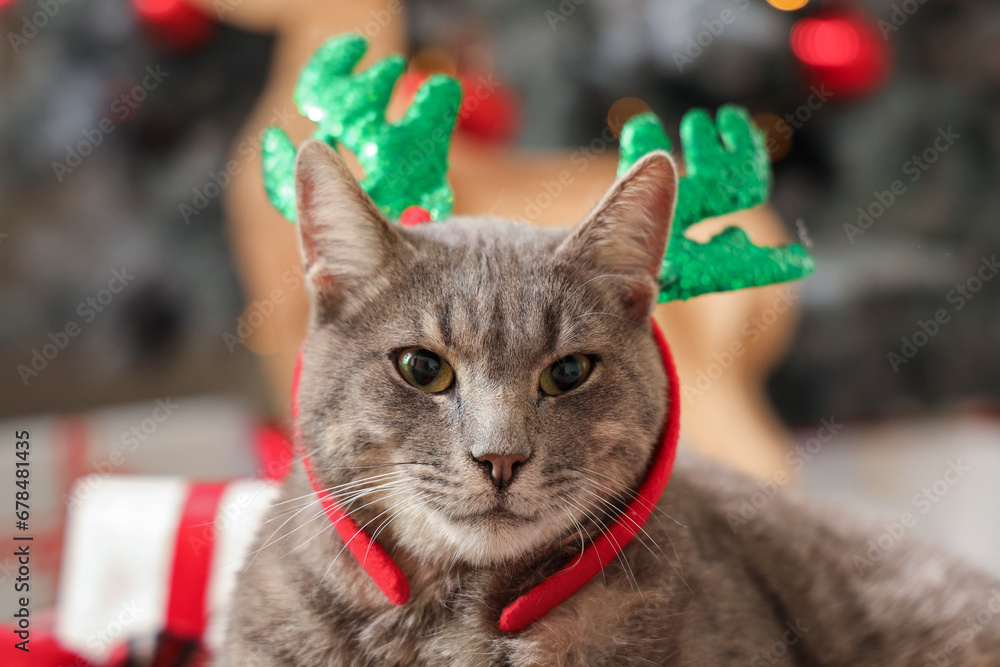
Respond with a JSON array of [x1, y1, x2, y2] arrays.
[[220, 141, 1000, 667]]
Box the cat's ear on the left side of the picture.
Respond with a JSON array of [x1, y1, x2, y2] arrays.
[[295, 139, 410, 316]]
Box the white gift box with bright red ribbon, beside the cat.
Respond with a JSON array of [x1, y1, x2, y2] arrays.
[[49, 476, 278, 665]]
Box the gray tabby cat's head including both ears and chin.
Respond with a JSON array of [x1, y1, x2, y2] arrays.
[[297, 142, 676, 564]]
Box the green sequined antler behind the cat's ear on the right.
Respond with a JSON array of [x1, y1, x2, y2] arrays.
[[618, 106, 815, 303]]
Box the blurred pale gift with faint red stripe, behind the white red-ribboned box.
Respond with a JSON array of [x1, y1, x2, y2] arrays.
[[0, 397, 259, 619]]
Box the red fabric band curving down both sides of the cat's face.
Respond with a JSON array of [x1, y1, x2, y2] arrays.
[[292, 319, 681, 632]]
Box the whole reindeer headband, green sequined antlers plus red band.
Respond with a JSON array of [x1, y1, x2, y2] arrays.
[[263, 35, 813, 632]]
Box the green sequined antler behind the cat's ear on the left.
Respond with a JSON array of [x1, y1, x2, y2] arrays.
[[262, 34, 462, 221]]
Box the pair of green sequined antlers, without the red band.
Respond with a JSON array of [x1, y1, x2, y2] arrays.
[[263, 35, 815, 302]]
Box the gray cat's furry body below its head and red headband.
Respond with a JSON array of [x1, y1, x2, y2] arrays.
[[227, 457, 1000, 667]]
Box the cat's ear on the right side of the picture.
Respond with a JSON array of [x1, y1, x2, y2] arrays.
[[557, 151, 677, 321]]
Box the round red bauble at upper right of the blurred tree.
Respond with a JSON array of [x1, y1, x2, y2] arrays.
[[790, 12, 890, 98]]
